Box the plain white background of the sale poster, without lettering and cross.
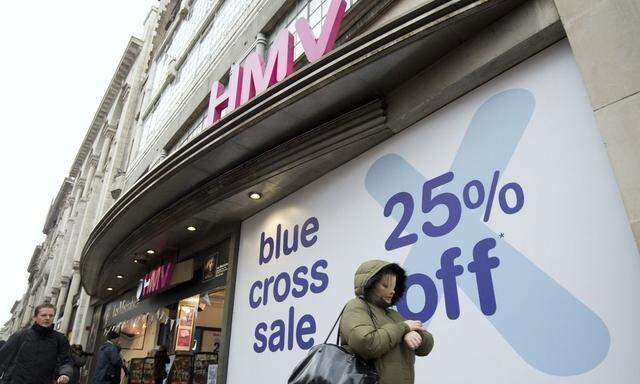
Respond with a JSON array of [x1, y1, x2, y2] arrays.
[[228, 41, 640, 384]]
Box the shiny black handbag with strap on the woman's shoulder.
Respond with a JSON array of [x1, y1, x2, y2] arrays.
[[287, 308, 378, 384]]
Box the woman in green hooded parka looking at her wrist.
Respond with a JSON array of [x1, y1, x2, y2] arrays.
[[340, 260, 433, 384]]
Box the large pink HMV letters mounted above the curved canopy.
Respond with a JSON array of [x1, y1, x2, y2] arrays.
[[206, 0, 347, 127]]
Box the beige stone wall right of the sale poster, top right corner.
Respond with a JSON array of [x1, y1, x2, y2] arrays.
[[555, 0, 640, 249]]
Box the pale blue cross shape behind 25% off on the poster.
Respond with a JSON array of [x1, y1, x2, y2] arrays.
[[365, 89, 610, 376]]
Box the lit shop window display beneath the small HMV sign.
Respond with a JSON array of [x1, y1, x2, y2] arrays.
[[118, 243, 227, 384]]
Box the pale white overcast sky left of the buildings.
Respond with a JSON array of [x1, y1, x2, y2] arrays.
[[0, 0, 158, 327]]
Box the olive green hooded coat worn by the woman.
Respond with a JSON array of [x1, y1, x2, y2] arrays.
[[340, 260, 433, 384]]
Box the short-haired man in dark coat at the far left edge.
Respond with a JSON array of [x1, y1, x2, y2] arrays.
[[0, 304, 73, 384]]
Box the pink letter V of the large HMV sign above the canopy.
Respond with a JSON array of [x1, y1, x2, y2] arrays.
[[296, 0, 347, 63]]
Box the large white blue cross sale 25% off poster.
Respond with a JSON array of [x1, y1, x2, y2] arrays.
[[228, 41, 640, 384]]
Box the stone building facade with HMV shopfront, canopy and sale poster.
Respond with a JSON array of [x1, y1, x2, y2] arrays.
[[5, 0, 640, 383]]
